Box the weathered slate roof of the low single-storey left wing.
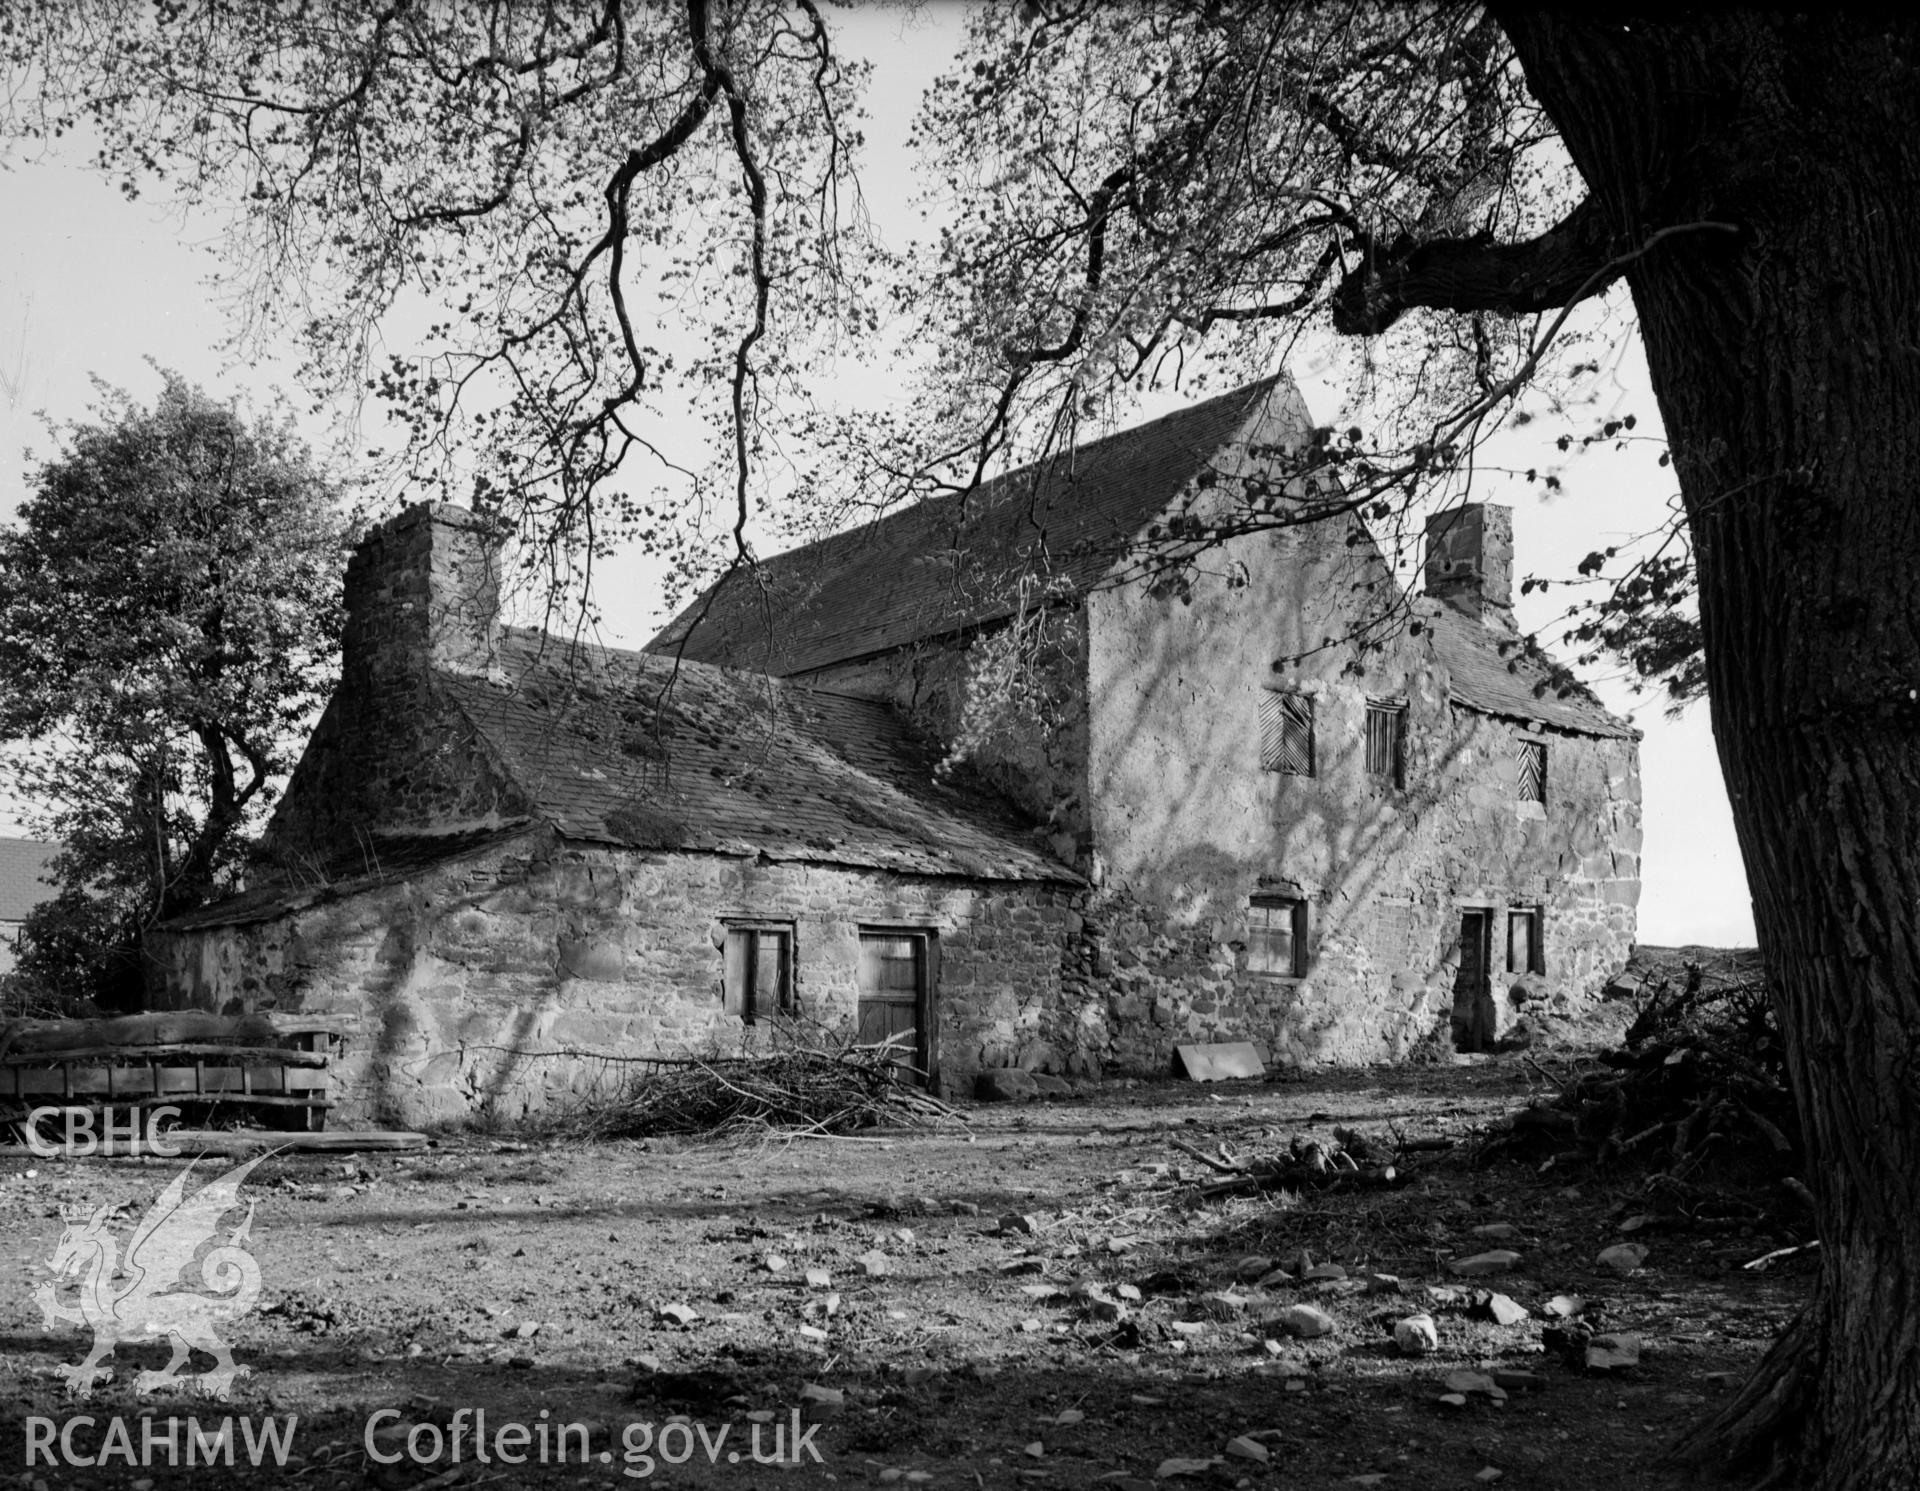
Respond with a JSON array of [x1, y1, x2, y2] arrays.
[[424, 627, 1077, 883]]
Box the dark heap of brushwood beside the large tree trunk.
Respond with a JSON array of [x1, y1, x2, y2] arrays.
[[1478, 963, 1811, 1205]]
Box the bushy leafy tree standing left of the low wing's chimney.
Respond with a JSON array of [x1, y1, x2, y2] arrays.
[[0, 374, 348, 1000]]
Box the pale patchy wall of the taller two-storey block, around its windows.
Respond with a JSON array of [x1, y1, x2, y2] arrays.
[[1068, 526, 1640, 1069]]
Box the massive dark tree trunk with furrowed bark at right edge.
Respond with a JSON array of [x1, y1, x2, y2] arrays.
[[1503, 10, 1920, 1491]]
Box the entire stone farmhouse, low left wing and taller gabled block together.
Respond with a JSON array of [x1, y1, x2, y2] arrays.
[[150, 378, 1640, 1123]]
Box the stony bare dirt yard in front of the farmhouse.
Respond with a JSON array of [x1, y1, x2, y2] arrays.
[[0, 1055, 1807, 1491]]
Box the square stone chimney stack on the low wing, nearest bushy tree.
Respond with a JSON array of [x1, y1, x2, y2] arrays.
[[342, 503, 501, 686]]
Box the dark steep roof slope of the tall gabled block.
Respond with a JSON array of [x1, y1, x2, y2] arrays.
[[647, 374, 1308, 675]]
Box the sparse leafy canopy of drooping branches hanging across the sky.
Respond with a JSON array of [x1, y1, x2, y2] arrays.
[[0, 0, 1712, 694]]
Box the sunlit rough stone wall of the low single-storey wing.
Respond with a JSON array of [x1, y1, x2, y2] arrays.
[[152, 833, 1079, 1124]]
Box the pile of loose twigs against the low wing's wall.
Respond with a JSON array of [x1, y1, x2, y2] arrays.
[[555, 1044, 964, 1138]]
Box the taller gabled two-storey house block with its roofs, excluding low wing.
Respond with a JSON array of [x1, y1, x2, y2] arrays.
[[653, 378, 1640, 1071]]
